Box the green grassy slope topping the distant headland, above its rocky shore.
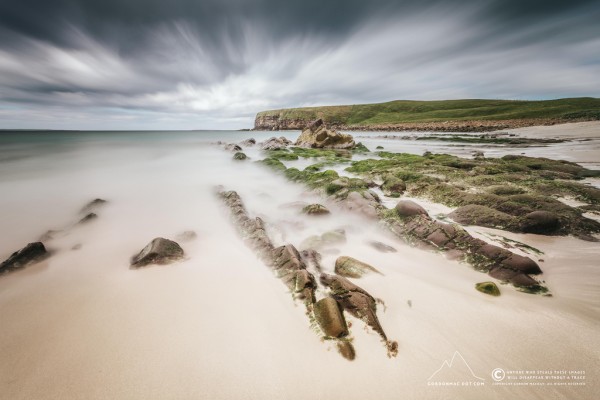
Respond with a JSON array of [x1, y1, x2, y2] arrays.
[[257, 97, 600, 126]]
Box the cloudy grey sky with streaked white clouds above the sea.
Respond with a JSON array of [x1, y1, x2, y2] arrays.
[[0, 0, 600, 130]]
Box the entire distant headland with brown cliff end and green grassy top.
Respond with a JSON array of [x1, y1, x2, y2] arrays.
[[254, 97, 600, 132]]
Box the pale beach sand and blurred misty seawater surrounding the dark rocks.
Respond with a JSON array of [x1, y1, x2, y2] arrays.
[[0, 122, 600, 400]]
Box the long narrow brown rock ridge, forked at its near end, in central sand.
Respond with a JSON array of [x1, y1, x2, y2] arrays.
[[218, 190, 398, 360]]
